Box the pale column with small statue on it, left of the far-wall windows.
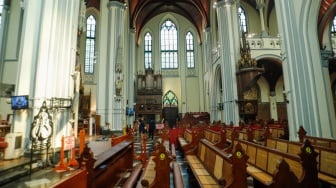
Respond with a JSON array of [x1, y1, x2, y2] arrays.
[[97, 0, 125, 130]]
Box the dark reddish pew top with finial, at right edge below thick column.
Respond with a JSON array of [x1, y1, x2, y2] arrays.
[[297, 125, 336, 149]]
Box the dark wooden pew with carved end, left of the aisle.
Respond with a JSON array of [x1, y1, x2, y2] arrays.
[[78, 140, 134, 188]]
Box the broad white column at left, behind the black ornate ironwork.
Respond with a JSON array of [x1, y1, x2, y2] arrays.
[[14, 0, 80, 147]]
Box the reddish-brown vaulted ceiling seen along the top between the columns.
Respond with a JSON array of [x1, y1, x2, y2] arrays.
[[86, 0, 336, 47]]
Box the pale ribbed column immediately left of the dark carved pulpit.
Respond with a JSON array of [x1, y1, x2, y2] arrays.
[[216, 0, 240, 125]]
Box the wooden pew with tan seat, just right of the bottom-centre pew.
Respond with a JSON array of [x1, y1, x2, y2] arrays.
[[186, 139, 248, 188]]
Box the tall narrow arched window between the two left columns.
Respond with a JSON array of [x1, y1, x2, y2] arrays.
[[84, 15, 96, 74]]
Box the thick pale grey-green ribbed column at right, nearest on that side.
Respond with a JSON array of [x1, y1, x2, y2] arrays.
[[275, 0, 336, 140]]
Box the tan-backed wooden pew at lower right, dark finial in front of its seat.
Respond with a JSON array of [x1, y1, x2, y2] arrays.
[[238, 140, 318, 187]]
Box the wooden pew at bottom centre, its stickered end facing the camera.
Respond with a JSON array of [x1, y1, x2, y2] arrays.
[[138, 144, 183, 188]]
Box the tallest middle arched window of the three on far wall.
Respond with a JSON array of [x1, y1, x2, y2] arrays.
[[160, 19, 178, 69]]
